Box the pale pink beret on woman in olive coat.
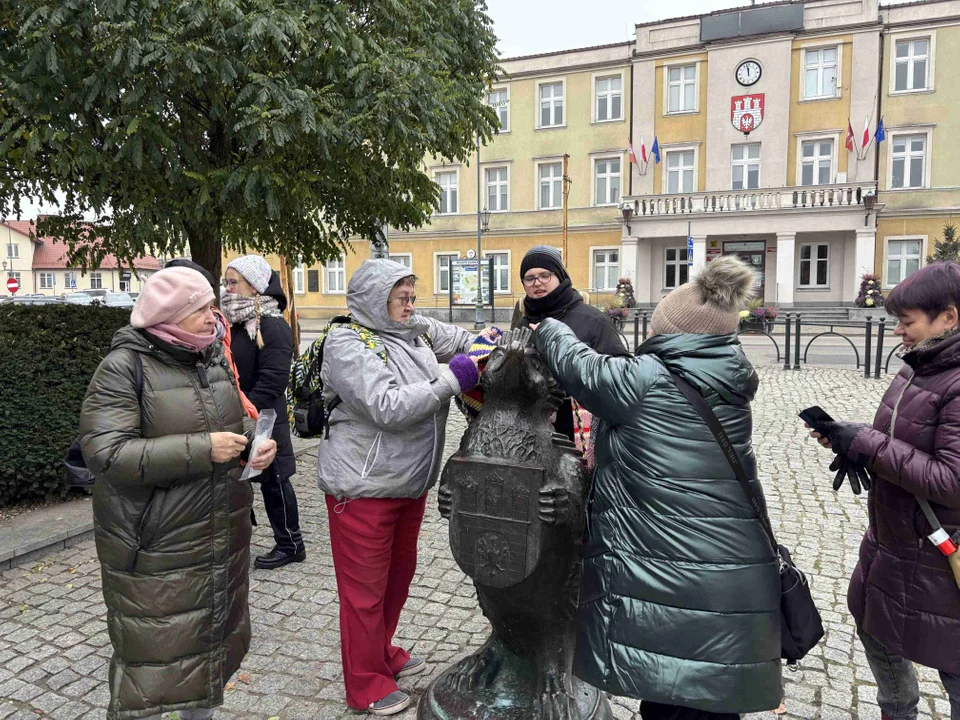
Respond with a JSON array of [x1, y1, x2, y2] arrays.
[[130, 267, 214, 328]]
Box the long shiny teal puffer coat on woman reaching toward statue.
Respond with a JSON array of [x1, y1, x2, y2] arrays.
[[536, 320, 781, 713]]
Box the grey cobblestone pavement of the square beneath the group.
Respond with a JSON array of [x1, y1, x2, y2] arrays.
[[0, 367, 949, 720]]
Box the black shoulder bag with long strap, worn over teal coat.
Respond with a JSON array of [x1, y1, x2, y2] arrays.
[[670, 373, 823, 666]]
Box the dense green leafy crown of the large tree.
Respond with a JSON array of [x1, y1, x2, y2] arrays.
[[0, 0, 498, 274]]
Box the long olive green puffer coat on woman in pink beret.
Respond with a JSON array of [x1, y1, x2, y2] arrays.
[[80, 327, 253, 720]]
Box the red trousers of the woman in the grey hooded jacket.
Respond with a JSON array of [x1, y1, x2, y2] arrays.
[[327, 495, 427, 710]]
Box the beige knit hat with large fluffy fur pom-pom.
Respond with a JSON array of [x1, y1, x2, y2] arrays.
[[651, 255, 756, 335]]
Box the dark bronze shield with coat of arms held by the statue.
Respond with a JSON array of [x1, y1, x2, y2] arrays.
[[447, 457, 543, 587]]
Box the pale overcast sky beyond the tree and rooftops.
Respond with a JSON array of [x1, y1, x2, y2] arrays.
[[11, 0, 750, 219]]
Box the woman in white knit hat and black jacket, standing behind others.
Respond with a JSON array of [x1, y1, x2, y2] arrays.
[[220, 255, 307, 569]]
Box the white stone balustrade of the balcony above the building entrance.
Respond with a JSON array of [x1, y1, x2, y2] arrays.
[[624, 183, 876, 217]]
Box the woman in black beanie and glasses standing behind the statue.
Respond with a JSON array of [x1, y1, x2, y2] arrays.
[[511, 245, 630, 440]]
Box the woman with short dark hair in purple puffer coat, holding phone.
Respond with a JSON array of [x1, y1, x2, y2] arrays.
[[813, 262, 960, 720]]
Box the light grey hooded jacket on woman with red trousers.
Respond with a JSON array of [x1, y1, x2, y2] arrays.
[[317, 260, 474, 499]]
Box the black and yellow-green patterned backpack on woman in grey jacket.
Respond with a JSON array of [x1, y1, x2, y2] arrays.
[[286, 315, 387, 438]]
